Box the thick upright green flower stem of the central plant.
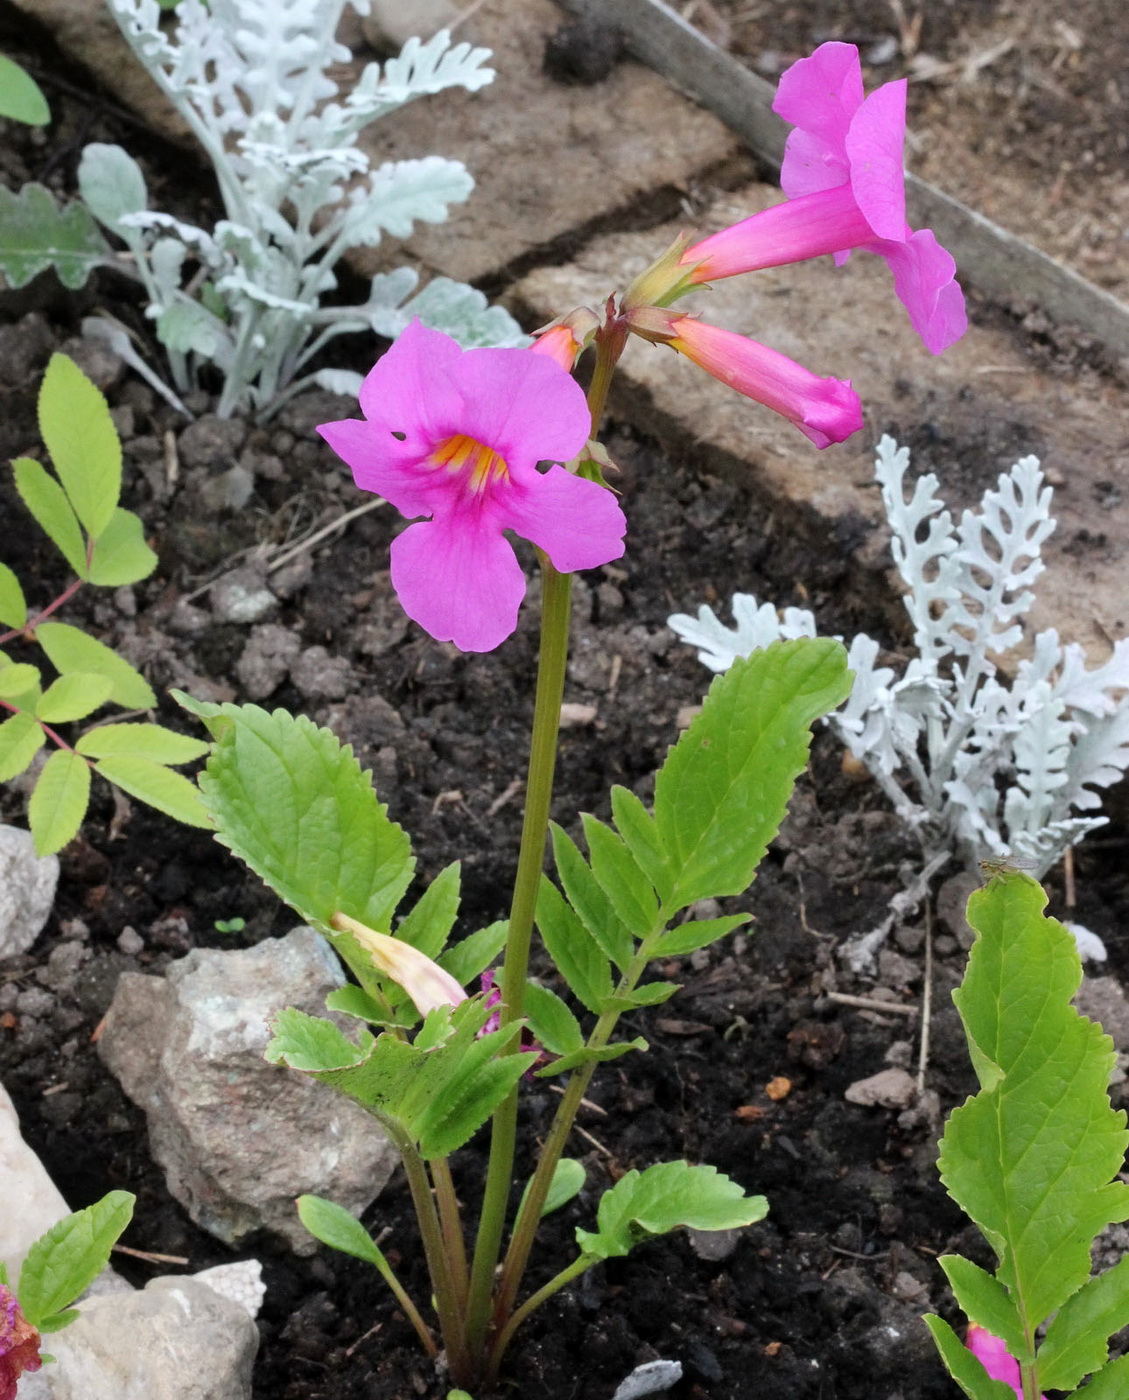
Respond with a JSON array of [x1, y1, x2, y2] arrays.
[[466, 560, 572, 1355]]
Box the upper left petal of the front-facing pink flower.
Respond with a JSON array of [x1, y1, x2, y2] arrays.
[[360, 319, 464, 447]]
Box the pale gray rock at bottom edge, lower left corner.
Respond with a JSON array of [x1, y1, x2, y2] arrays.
[[20, 1277, 259, 1400]]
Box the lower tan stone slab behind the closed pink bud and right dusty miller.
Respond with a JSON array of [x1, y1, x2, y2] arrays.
[[514, 185, 1129, 655]]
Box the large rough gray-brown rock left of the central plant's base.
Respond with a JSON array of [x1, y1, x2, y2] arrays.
[[98, 928, 395, 1253]]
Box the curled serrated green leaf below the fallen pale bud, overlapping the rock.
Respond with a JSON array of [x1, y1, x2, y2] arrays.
[[271, 998, 536, 1158]]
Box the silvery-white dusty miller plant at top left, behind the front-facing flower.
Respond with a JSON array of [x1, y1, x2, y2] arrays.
[[0, 0, 524, 416]]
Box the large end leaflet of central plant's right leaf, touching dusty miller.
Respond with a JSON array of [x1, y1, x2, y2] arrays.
[[654, 638, 850, 913]]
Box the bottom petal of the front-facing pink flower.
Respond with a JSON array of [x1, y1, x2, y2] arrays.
[[392, 512, 529, 651]]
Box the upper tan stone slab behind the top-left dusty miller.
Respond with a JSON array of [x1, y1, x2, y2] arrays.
[[15, 0, 740, 281]]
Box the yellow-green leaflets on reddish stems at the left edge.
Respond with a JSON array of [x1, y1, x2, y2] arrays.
[[0, 354, 209, 855]]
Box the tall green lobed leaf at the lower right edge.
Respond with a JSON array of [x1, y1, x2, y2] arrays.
[[926, 871, 1129, 1400]]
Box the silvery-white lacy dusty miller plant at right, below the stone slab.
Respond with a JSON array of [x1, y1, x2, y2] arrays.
[[670, 437, 1129, 963]]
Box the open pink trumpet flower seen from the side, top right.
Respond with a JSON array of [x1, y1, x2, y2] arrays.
[[679, 43, 968, 354]]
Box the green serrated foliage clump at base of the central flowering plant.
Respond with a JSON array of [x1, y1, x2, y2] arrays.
[[179, 641, 849, 1385]]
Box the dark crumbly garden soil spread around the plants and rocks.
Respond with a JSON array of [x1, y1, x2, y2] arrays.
[[0, 10, 1129, 1400]]
